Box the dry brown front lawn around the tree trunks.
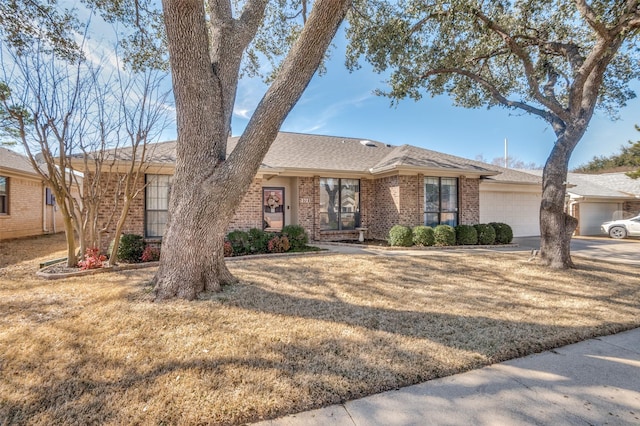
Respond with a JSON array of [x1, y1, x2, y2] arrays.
[[0, 236, 640, 425]]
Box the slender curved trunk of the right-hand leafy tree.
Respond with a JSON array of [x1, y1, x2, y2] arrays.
[[540, 125, 586, 269]]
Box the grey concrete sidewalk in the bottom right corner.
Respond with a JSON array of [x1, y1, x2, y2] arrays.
[[258, 329, 640, 426]]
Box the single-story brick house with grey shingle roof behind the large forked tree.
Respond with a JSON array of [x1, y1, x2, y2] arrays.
[[76, 132, 541, 248]]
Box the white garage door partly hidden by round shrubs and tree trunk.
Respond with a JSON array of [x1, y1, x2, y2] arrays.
[[480, 191, 540, 237]]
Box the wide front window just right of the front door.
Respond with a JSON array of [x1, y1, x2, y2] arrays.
[[320, 178, 360, 231]]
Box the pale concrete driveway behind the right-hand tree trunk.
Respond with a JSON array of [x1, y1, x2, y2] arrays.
[[513, 237, 640, 265]]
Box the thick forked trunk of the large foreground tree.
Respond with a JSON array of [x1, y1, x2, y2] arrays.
[[155, 0, 350, 300]]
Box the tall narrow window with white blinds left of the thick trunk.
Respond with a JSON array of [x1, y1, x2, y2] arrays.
[[145, 175, 173, 237]]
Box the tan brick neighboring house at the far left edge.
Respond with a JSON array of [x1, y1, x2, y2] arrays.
[[0, 147, 64, 240]]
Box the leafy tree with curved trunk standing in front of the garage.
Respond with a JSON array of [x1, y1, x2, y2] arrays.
[[348, 0, 640, 268]]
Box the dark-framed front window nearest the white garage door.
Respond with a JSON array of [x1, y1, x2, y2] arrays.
[[424, 177, 458, 226]]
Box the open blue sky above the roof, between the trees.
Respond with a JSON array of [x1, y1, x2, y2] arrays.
[[232, 35, 640, 167]]
